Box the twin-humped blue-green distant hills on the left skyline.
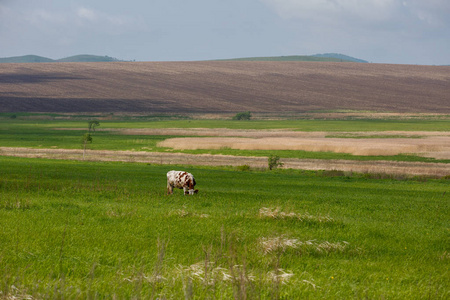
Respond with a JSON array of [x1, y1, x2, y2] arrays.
[[0, 54, 121, 63]]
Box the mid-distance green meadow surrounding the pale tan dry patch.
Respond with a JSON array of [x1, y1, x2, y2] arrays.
[[0, 118, 450, 163]]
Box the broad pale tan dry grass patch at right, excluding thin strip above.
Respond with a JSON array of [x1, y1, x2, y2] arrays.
[[158, 135, 450, 159]]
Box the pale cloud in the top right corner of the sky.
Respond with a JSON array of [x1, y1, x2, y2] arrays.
[[261, 0, 450, 29]]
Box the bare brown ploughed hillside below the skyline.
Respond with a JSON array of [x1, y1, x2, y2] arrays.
[[0, 61, 450, 113]]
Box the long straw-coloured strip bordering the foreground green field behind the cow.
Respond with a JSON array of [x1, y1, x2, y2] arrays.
[[0, 147, 450, 176]]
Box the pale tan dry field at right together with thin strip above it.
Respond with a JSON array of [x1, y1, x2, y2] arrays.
[[156, 129, 450, 159]]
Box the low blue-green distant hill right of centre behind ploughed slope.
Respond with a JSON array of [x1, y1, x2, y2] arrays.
[[214, 53, 367, 63]]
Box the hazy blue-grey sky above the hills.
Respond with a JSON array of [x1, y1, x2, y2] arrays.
[[0, 0, 450, 65]]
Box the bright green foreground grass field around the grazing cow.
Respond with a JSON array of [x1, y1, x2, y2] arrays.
[[0, 156, 450, 299]]
